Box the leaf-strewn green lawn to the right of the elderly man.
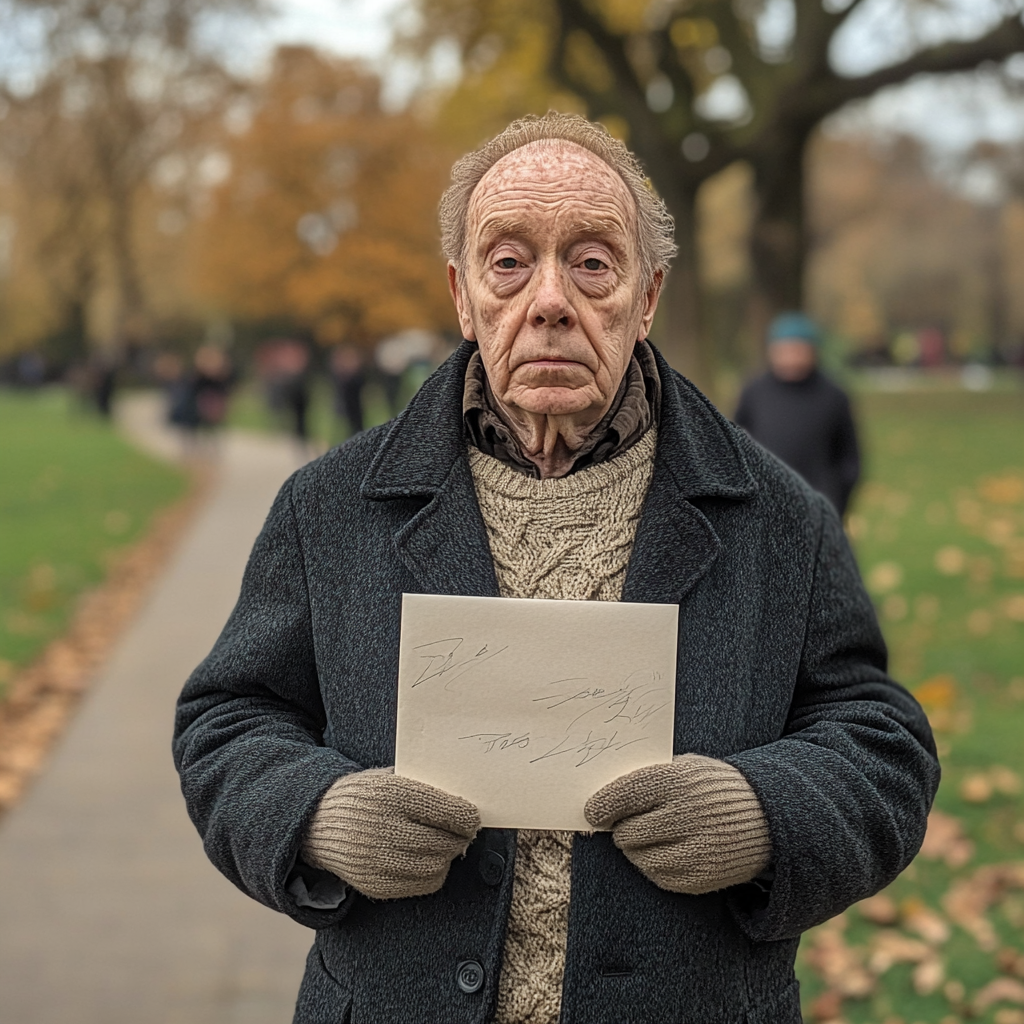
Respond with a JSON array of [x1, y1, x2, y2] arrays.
[[799, 392, 1024, 1024]]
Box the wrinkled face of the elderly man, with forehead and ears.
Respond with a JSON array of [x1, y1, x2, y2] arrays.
[[449, 141, 660, 416]]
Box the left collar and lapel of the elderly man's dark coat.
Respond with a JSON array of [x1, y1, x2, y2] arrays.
[[361, 342, 498, 597]]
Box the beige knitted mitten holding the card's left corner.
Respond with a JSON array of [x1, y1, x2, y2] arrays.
[[302, 768, 480, 899]]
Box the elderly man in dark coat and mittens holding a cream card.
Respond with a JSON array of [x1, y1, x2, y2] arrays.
[[175, 115, 938, 1024]]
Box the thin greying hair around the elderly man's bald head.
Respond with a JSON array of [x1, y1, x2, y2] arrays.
[[439, 111, 676, 287]]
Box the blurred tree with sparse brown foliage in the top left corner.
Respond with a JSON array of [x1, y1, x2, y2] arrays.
[[3, 0, 264, 346]]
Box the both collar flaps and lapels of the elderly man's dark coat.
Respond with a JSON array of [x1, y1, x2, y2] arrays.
[[361, 343, 757, 604]]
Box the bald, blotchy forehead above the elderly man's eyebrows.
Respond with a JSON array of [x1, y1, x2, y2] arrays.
[[469, 139, 636, 237]]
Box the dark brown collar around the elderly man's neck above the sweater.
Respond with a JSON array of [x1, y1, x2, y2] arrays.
[[462, 341, 662, 479]]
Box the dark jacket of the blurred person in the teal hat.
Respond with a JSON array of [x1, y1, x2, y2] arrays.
[[734, 370, 860, 515]]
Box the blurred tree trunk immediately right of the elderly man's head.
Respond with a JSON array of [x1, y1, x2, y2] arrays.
[[651, 182, 715, 397]]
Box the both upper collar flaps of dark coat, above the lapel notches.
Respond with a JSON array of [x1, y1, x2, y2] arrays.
[[361, 342, 757, 501]]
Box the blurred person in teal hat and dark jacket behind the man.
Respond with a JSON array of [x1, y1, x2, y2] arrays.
[[734, 312, 860, 515]]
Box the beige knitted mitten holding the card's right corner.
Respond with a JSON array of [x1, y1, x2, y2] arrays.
[[584, 754, 771, 894]]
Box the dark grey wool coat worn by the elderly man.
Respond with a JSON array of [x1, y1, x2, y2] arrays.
[[174, 343, 939, 1024]]
